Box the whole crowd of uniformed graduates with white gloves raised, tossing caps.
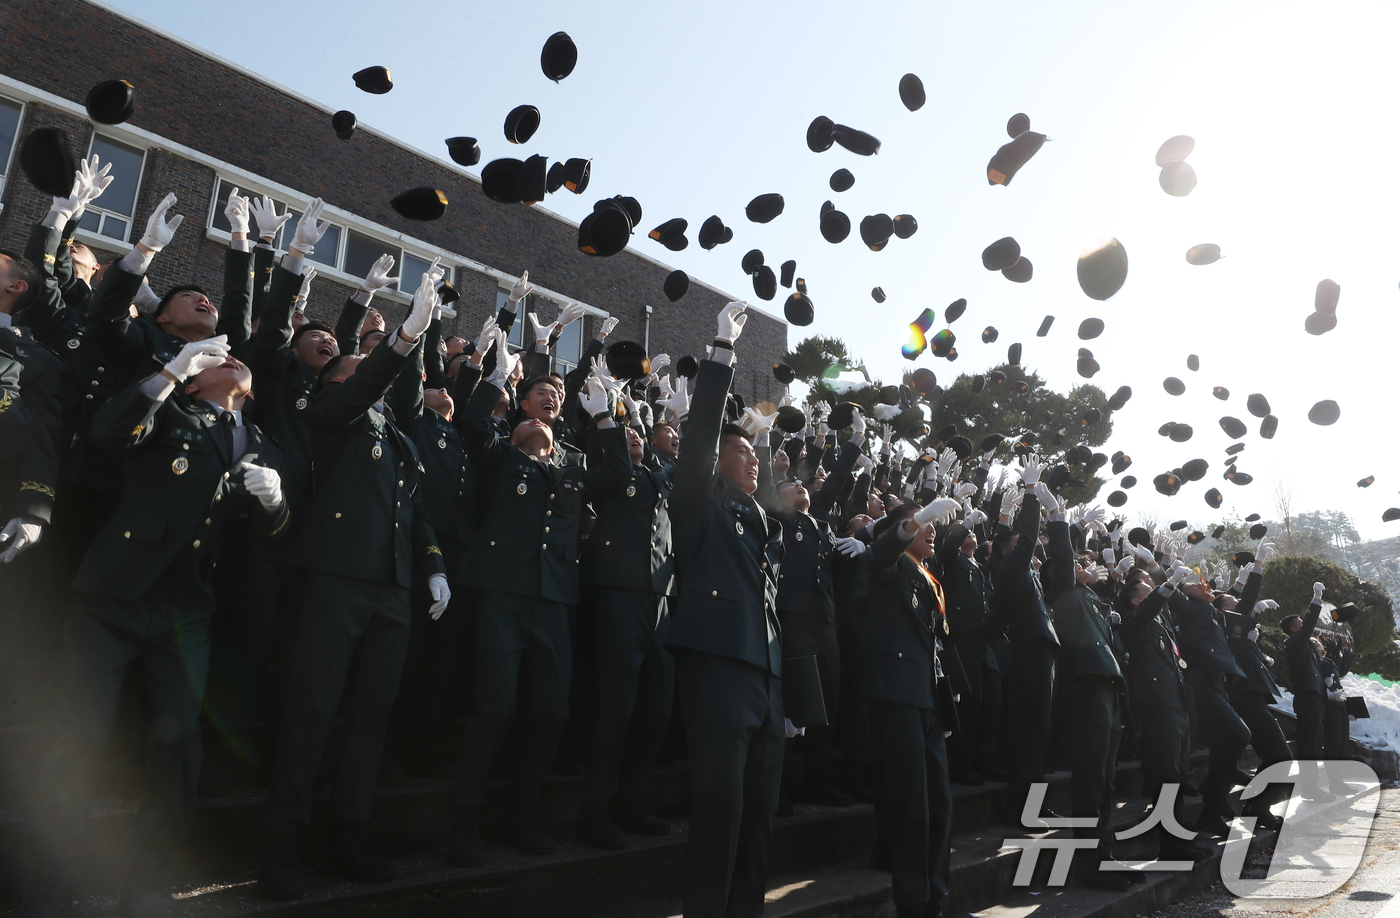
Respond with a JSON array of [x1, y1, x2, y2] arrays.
[[0, 158, 1350, 917]]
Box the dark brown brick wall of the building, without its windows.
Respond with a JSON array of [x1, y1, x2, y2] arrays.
[[0, 0, 787, 404]]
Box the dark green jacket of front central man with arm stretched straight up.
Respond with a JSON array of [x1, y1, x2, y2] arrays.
[[666, 360, 783, 675]]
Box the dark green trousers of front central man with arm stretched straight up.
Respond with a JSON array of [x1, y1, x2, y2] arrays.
[[676, 651, 784, 918]]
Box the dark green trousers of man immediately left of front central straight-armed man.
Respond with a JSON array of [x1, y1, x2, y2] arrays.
[[582, 589, 676, 800]]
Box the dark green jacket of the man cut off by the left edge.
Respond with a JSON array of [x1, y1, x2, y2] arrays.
[[0, 326, 71, 526]]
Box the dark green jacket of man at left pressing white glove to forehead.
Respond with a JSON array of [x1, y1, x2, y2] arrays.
[[73, 383, 290, 613]]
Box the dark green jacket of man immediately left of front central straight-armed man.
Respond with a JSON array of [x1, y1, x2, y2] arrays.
[[581, 427, 676, 596]]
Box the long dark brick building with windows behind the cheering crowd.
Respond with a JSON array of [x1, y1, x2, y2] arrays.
[[0, 0, 787, 404]]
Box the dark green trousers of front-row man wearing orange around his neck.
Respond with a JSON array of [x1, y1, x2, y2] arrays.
[[865, 698, 953, 908]]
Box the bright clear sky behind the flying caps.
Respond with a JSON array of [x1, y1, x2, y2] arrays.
[[101, 0, 1400, 537]]
